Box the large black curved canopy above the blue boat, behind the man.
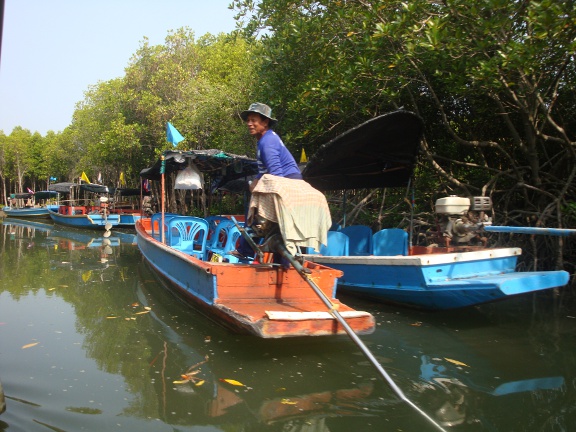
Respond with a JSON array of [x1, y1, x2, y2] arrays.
[[302, 111, 424, 190]]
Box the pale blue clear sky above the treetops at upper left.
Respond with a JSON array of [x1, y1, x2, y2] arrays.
[[0, 0, 236, 136]]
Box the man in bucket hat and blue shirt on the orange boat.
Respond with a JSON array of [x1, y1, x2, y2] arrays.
[[240, 102, 302, 191]]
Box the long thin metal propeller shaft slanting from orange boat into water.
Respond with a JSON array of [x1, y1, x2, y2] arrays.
[[274, 239, 446, 432]]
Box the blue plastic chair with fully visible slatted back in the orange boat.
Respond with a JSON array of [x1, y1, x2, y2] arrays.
[[167, 216, 208, 260]]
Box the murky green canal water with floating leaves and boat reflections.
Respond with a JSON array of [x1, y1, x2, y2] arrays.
[[0, 221, 576, 432]]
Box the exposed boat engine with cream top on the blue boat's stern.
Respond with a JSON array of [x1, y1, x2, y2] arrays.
[[435, 195, 492, 246]]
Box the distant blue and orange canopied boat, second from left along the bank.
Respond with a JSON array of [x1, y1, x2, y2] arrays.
[[48, 183, 120, 230]]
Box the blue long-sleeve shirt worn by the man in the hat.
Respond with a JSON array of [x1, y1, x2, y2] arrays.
[[256, 129, 302, 180]]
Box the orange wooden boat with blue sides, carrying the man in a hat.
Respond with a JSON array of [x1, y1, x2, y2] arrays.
[[136, 150, 374, 338]]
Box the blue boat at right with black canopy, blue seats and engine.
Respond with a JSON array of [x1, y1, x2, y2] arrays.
[[303, 111, 569, 310]]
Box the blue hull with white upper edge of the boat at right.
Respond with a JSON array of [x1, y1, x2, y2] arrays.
[[305, 248, 569, 310]]
